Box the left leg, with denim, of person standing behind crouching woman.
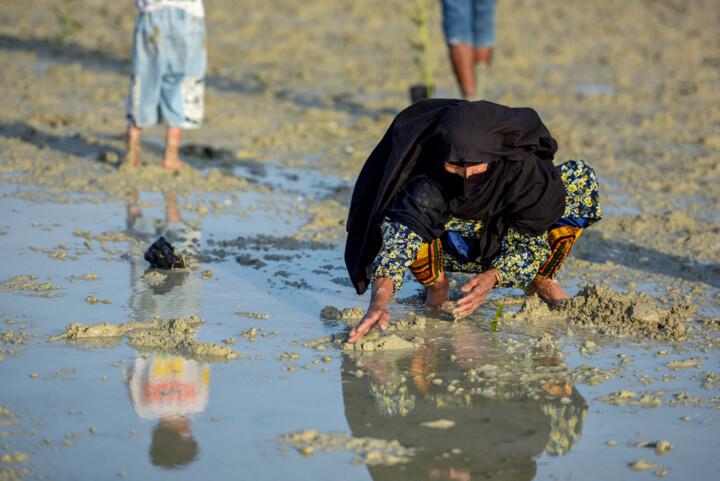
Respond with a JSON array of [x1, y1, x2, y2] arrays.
[[442, 0, 477, 99]]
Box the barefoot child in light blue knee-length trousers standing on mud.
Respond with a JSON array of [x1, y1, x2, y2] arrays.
[[125, 0, 207, 169]]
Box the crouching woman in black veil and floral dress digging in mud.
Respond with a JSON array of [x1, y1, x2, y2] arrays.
[[345, 99, 600, 342]]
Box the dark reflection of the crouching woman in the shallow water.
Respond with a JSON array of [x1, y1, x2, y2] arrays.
[[343, 325, 587, 480]]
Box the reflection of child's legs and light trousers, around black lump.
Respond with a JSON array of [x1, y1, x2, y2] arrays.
[[126, 191, 202, 318]]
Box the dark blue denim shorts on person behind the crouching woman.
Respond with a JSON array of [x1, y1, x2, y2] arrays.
[[441, 0, 497, 48]]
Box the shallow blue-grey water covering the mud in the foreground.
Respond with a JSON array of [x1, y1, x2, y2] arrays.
[[0, 181, 720, 480]]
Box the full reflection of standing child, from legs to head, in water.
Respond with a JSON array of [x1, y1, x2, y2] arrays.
[[123, 191, 210, 468]]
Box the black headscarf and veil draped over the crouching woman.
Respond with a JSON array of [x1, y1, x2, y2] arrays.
[[345, 99, 565, 294]]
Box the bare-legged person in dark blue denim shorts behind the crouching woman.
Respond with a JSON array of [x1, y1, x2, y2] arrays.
[[441, 0, 497, 100]]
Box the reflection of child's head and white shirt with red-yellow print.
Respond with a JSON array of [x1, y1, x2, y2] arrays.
[[124, 355, 210, 468]]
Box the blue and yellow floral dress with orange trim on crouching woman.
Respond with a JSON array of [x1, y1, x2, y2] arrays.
[[370, 160, 602, 292]]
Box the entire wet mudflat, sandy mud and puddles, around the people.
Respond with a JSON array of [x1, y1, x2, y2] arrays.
[[0, 0, 720, 480]]
